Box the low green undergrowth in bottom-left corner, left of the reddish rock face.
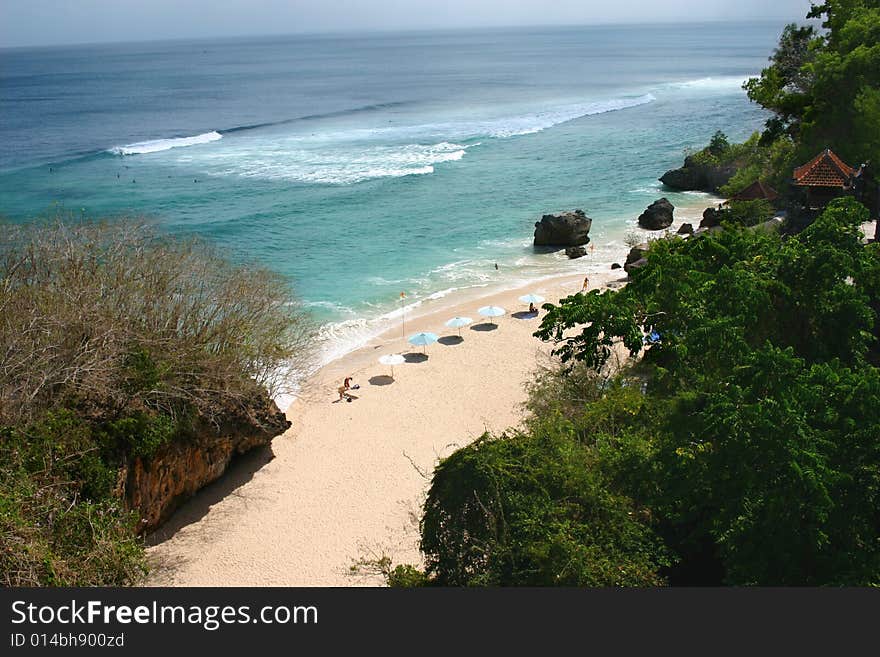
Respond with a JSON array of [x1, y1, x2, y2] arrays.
[[0, 411, 145, 586]]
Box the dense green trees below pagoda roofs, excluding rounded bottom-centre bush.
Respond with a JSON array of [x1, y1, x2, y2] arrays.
[[520, 198, 880, 585]]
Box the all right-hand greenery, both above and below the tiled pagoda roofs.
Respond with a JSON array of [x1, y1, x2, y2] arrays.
[[394, 0, 880, 586]]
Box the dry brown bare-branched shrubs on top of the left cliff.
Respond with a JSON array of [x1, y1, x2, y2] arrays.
[[0, 221, 309, 423]]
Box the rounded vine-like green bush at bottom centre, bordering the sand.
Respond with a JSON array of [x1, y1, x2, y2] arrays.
[[421, 432, 666, 586]]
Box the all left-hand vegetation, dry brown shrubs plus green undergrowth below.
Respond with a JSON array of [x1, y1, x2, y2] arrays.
[[0, 220, 311, 586]]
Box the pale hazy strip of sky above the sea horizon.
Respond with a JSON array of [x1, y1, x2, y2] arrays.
[[0, 0, 810, 47]]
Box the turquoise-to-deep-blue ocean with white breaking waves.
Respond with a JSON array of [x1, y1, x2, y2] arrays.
[[0, 23, 783, 364]]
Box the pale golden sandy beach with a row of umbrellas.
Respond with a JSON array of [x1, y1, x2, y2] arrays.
[[143, 270, 625, 586]]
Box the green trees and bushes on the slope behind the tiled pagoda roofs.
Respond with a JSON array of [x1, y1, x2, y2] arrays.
[[692, 0, 880, 205]]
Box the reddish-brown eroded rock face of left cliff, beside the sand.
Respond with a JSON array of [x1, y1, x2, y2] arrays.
[[121, 398, 290, 532]]
